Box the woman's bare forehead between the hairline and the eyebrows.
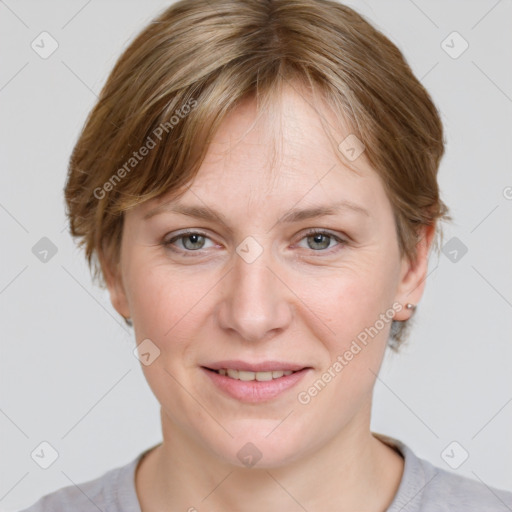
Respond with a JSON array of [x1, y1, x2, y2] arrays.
[[140, 83, 387, 218]]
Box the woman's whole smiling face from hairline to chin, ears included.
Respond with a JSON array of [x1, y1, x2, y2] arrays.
[[109, 84, 426, 467]]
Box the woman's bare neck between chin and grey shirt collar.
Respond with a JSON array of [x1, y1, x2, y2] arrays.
[[136, 410, 403, 512]]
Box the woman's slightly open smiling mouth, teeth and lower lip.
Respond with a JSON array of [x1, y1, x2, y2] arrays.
[[201, 364, 313, 404]]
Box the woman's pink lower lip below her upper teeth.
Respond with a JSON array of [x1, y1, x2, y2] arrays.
[[201, 363, 312, 404]]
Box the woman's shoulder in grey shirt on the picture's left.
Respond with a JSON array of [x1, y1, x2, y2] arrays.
[[20, 452, 146, 512]]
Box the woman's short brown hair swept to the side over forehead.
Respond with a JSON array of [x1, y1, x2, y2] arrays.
[[65, 0, 451, 350]]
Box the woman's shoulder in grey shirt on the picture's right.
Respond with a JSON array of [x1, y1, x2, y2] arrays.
[[374, 434, 512, 512]]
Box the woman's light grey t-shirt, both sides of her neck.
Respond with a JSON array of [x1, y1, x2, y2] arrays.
[[21, 433, 512, 512]]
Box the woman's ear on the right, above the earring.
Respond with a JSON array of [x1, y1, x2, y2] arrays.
[[394, 223, 436, 321]]
